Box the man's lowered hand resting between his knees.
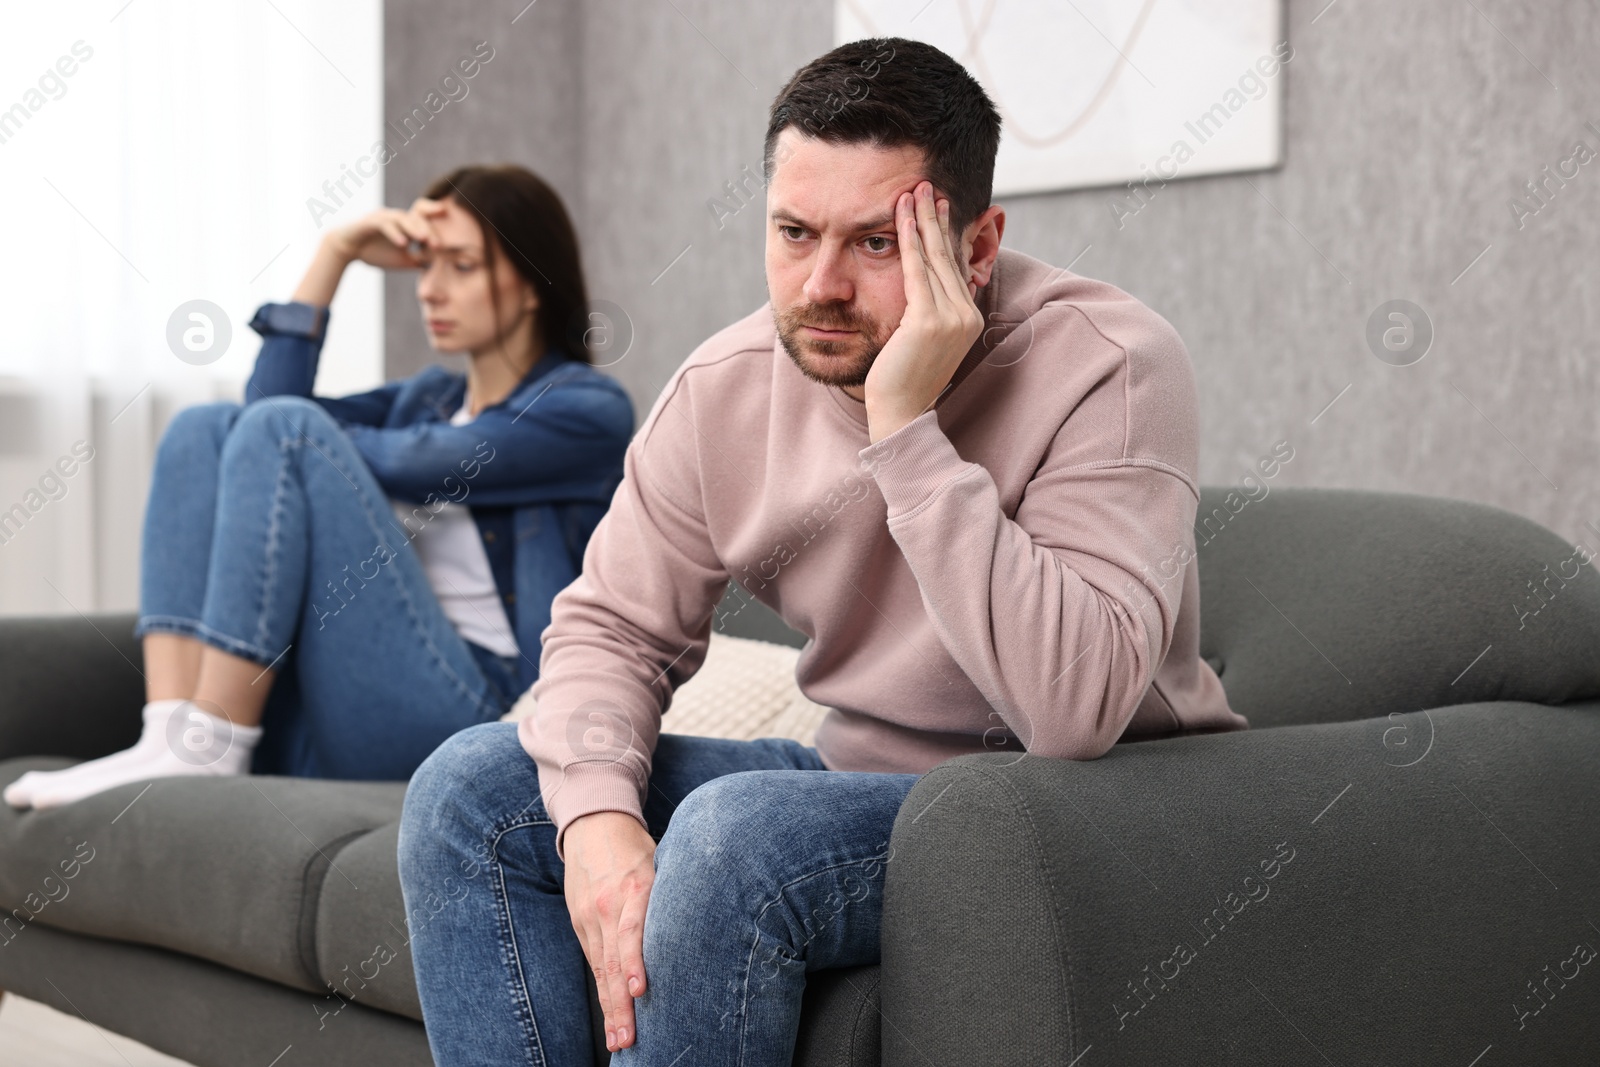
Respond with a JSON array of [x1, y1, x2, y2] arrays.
[[562, 811, 656, 1051]]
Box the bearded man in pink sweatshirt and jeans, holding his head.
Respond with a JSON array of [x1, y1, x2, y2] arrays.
[[400, 38, 1246, 1067]]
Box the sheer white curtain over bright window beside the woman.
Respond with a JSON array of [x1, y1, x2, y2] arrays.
[[0, 0, 382, 614]]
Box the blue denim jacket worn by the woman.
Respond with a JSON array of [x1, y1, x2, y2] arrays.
[[245, 301, 634, 689]]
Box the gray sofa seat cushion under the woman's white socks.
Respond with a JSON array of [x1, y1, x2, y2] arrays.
[[0, 757, 405, 992]]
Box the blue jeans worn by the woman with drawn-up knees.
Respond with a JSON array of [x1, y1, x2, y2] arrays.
[[134, 397, 520, 781]]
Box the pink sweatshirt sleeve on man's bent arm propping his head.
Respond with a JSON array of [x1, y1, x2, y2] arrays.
[[859, 396, 1198, 760]]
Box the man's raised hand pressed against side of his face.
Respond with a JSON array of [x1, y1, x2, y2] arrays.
[[864, 181, 984, 443]]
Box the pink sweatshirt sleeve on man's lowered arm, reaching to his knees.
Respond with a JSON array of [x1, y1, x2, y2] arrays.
[[517, 371, 728, 861]]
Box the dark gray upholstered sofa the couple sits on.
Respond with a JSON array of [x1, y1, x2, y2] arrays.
[[0, 486, 1600, 1067]]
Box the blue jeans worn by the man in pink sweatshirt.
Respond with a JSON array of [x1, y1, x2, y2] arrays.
[[398, 723, 918, 1067]]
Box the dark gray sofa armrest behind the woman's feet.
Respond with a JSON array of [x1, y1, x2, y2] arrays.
[[0, 613, 144, 760]]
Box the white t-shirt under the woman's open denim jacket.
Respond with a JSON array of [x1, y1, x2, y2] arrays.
[[389, 398, 517, 656]]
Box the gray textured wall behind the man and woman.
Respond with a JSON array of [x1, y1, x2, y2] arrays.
[[386, 0, 1600, 547]]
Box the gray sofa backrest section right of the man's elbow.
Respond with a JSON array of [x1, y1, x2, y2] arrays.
[[1195, 483, 1600, 726]]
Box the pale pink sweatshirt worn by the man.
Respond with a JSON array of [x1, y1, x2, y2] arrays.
[[518, 250, 1248, 857]]
